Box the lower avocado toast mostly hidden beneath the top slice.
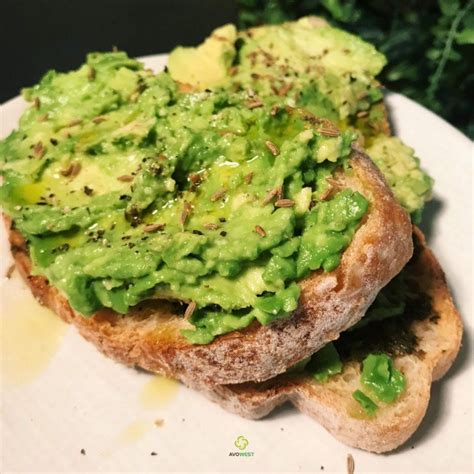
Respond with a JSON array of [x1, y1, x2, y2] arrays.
[[164, 15, 462, 452]]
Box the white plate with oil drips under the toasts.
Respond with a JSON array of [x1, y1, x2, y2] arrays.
[[1, 55, 473, 473]]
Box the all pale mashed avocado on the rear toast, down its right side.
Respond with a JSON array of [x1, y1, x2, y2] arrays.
[[168, 17, 433, 215]]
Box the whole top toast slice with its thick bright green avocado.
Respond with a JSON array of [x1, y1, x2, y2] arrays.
[[1, 45, 412, 384]]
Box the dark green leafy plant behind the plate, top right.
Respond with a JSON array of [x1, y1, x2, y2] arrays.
[[238, 0, 474, 138]]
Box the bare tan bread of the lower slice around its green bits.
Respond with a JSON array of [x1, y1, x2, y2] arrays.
[[193, 228, 462, 453]]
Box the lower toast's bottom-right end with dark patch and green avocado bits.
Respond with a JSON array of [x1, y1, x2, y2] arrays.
[[191, 228, 462, 453]]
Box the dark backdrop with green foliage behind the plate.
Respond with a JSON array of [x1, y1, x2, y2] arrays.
[[0, 0, 474, 137]]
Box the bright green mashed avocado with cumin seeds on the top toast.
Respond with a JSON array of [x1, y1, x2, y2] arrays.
[[0, 51, 368, 343]]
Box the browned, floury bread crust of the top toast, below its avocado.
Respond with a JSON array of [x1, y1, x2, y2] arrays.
[[3, 150, 413, 384]]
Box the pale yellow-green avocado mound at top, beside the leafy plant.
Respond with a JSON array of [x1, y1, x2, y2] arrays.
[[168, 17, 386, 134]]
